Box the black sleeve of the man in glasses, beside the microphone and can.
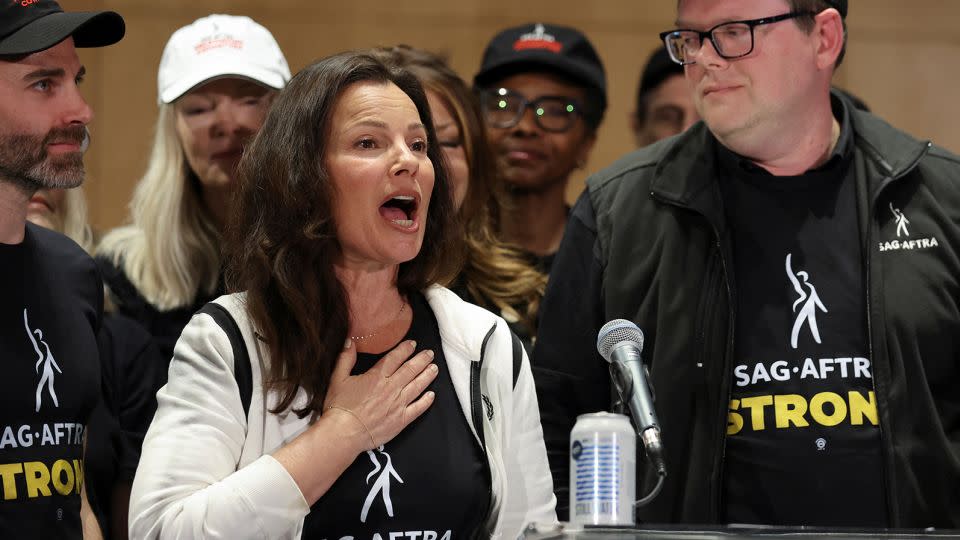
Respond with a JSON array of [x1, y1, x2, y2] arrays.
[[533, 192, 610, 520]]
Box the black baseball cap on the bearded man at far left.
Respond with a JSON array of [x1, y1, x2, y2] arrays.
[[0, 0, 126, 56]]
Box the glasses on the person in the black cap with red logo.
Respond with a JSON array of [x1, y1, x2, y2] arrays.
[[480, 88, 582, 133]]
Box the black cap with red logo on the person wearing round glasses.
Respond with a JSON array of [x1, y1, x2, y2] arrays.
[[473, 23, 607, 124]]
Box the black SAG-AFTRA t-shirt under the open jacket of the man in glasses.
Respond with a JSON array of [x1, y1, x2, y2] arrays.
[[717, 102, 887, 526]]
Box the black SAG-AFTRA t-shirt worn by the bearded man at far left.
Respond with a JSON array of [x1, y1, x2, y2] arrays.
[[0, 223, 103, 538]]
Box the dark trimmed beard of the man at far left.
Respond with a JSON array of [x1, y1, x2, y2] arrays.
[[0, 126, 89, 193]]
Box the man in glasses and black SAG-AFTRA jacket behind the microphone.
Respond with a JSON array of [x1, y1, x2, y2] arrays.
[[534, 0, 960, 528]]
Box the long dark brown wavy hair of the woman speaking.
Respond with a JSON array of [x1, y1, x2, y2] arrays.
[[224, 51, 462, 417]]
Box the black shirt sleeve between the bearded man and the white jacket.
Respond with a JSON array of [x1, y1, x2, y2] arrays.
[[86, 313, 170, 538]]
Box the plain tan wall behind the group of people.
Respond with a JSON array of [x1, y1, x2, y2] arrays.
[[67, 0, 960, 230]]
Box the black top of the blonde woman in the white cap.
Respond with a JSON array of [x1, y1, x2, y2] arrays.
[[96, 257, 224, 362]]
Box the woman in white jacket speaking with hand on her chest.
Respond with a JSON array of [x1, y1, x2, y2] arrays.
[[130, 52, 556, 540]]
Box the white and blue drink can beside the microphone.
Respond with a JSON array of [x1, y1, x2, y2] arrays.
[[570, 412, 637, 525]]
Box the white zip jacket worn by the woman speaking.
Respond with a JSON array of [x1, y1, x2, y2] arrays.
[[129, 286, 556, 540]]
